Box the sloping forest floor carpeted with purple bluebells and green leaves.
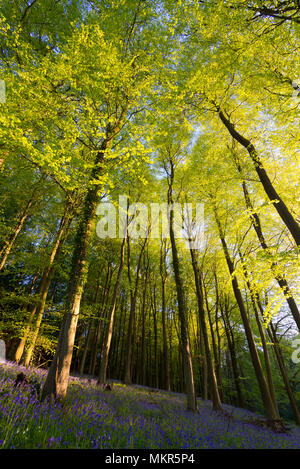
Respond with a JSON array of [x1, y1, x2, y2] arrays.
[[0, 362, 300, 449]]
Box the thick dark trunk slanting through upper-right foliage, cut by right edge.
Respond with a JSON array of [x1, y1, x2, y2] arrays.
[[218, 108, 300, 246]]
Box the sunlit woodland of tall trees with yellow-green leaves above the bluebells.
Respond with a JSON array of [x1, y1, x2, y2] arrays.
[[0, 0, 300, 425]]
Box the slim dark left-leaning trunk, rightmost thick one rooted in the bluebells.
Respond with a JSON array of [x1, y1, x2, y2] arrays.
[[214, 209, 279, 426]]
